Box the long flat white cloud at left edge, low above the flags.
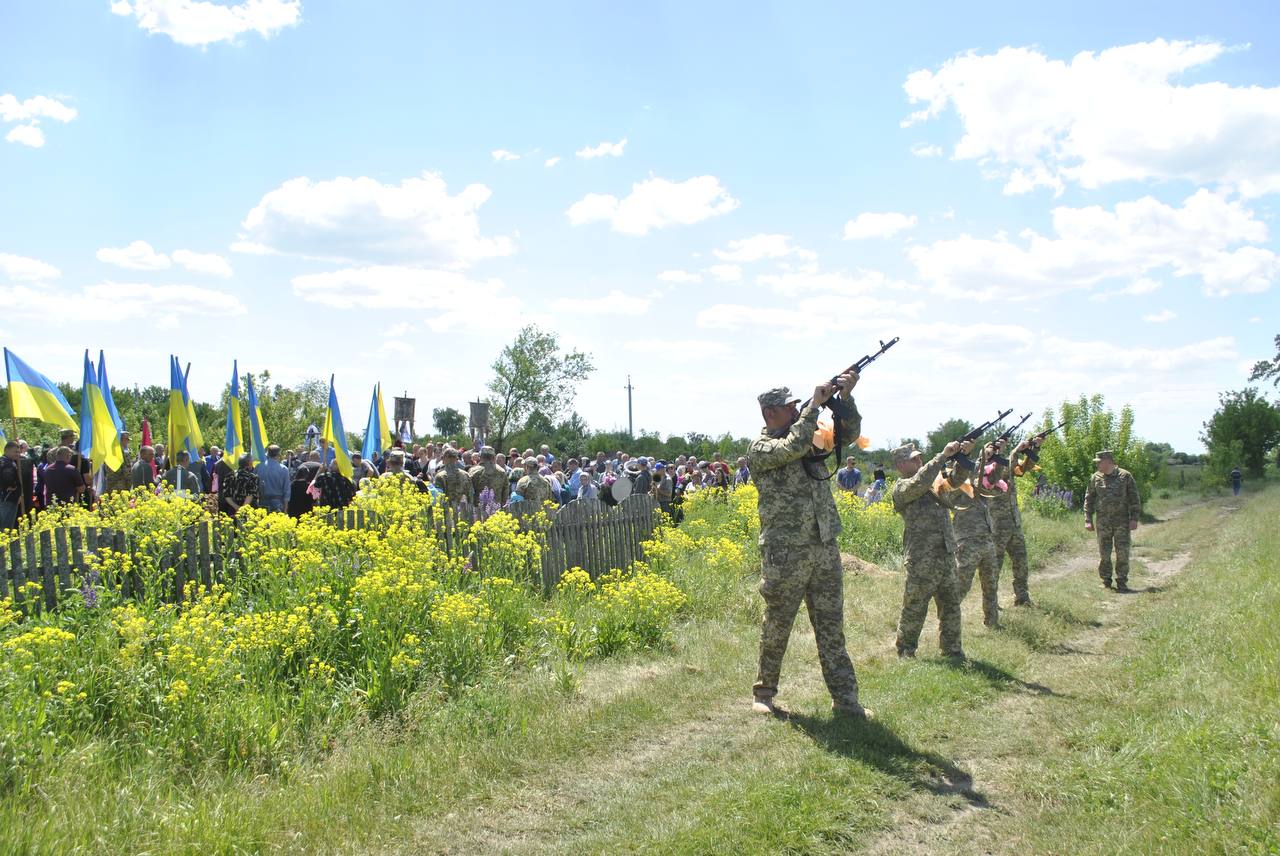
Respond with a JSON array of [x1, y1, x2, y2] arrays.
[[0, 280, 248, 322]]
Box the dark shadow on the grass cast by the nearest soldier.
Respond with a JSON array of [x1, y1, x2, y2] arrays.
[[786, 713, 991, 809]]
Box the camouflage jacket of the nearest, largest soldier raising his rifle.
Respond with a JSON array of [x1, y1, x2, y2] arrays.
[[748, 398, 863, 546]]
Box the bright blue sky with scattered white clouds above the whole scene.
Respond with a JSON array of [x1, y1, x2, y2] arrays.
[[0, 0, 1280, 449]]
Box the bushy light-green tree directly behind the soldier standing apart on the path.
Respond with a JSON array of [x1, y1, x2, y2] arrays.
[[1039, 395, 1161, 502]]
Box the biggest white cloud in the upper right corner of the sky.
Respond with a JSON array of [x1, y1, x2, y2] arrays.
[[902, 38, 1280, 196]]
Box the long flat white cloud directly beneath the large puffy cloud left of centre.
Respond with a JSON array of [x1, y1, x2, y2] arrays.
[[289, 265, 511, 312]]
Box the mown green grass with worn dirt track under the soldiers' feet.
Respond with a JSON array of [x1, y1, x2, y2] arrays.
[[0, 489, 1280, 853]]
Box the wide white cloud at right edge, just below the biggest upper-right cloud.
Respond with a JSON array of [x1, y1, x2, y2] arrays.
[[909, 189, 1280, 299]]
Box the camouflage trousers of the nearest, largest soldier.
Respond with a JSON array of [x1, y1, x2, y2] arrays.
[[755, 541, 858, 705]]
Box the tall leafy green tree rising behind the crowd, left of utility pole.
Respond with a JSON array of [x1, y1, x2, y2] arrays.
[[489, 325, 595, 445]]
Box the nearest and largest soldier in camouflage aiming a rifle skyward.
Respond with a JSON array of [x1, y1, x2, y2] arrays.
[[748, 372, 870, 717]]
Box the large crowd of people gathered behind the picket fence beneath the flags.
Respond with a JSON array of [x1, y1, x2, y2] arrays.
[[0, 430, 751, 528]]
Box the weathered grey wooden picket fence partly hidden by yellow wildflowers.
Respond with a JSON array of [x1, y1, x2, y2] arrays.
[[0, 495, 657, 610]]
